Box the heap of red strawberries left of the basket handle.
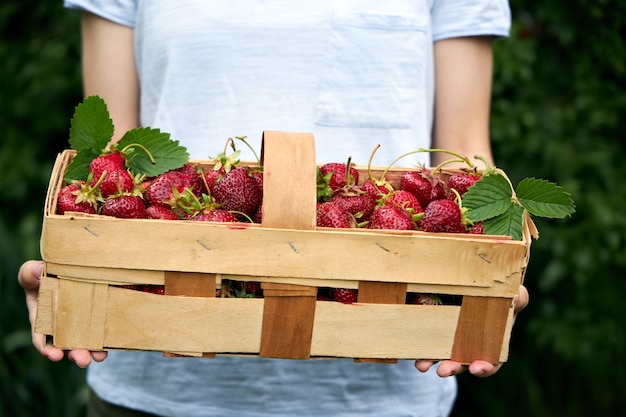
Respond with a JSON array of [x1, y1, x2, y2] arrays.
[[57, 152, 263, 222]]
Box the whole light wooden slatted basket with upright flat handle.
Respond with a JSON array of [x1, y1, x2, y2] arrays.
[[36, 131, 532, 363]]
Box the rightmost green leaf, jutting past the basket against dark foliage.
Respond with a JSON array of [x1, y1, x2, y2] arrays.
[[516, 178, 576, 219]]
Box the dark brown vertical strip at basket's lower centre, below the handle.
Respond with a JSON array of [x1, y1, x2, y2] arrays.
[[259, 283, 317, 359]]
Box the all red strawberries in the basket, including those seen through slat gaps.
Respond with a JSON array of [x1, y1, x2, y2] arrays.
[[57, 141, 482, 304]]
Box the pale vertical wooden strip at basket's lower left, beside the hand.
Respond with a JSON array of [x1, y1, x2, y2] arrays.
[[54, 279, 109, 350]]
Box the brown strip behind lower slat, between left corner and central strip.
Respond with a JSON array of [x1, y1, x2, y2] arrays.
[[163, 271, 216, 358]]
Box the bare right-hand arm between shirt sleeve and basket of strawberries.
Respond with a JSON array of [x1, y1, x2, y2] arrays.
[[431, 37, 493, 166]]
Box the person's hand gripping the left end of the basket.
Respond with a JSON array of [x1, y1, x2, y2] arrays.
[[17, 261, 107, 368]]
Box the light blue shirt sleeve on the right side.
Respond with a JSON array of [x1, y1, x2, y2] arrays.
[[431, 0, 511, 41]]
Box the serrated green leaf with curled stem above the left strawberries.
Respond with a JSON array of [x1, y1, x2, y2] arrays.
[[115, 127, 189, 177]]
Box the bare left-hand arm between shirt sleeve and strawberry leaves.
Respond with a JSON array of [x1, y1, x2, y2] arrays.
[[82, 12, 139, 141]]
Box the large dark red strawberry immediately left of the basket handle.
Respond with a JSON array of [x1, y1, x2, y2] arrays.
[[212, 168, 261, 217]]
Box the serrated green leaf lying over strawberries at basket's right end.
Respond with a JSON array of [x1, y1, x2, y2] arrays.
[[463, 174, 513, 222]]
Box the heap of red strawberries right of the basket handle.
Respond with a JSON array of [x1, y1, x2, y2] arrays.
[[317, 163, 483, 234]]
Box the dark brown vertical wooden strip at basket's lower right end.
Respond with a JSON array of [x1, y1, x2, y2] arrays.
[[451, 296, 513, 364]]
